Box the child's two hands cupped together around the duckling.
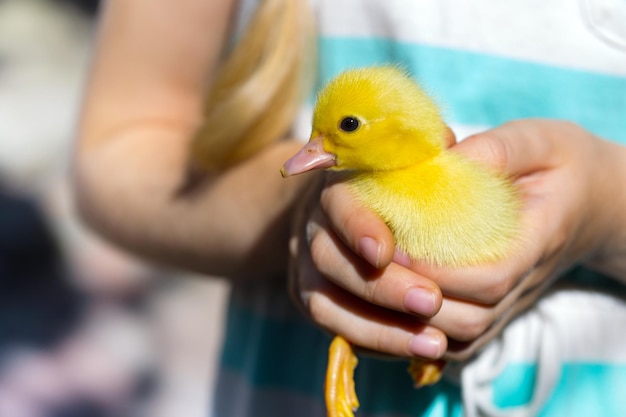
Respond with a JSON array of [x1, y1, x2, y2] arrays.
[[292, 120, 626, 359]]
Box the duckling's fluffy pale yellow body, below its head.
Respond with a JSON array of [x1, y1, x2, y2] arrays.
[[350, 152, 519, 267]]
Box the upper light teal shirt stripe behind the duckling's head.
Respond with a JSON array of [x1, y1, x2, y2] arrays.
[[319, 37, 626, 144]]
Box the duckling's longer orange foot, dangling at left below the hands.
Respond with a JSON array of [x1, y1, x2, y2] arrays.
[[324, 336, 359, 417]]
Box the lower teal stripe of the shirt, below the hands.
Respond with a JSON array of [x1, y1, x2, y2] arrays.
[[222, 292, 626, 417]]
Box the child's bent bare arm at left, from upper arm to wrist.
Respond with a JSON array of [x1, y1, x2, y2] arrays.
[[74, 0, 313, 280]]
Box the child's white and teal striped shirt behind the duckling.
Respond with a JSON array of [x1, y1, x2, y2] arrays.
[[212, 0, 626, 417]]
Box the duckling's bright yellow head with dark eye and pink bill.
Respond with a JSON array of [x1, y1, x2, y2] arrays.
[[281, 66, 451, 176]]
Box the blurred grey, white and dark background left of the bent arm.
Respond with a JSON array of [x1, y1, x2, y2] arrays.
[[0, 0, 228, 417]]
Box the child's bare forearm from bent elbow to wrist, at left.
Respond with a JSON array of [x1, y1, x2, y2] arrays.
[[75, 132, 310, 276]]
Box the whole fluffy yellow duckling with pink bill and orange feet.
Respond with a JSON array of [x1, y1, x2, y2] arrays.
[[281, 66, 519, 417]]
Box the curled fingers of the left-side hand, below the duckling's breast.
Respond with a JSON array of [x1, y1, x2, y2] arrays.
[[290, 174, 447, 358]]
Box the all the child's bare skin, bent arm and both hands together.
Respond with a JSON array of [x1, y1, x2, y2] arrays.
[[74, 0, 626, 358]]
